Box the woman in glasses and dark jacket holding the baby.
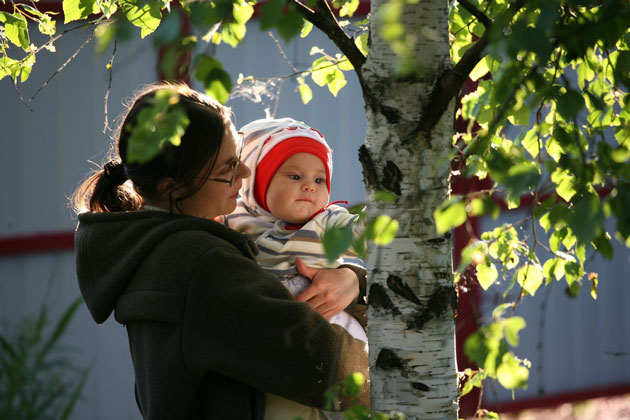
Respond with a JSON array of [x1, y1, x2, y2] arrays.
[[73, 85, 367, 420]]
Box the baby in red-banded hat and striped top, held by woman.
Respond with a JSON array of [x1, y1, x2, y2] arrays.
[[225, 118, 367, 420]]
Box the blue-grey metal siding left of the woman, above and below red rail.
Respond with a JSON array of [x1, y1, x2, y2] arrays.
[[0, 22, 157, 420]]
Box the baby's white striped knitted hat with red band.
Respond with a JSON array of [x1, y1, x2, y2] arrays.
[[230, 118, 333, 226]]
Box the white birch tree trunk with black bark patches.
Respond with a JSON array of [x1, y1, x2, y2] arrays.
[[360, 0, 458, 419]]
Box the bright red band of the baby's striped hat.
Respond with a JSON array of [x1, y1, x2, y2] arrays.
[[254, 131, 331, 210]]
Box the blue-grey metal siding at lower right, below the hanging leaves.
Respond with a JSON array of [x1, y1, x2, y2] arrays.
[[481, 211, 630, 403]]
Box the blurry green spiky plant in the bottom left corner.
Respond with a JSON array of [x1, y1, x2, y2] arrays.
[[0, 298, 88, 420]]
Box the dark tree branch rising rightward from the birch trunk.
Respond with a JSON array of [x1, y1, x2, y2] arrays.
[[410, 0, 526, 146]]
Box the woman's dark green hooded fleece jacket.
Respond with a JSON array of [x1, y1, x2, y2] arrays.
[[75, 211, 368, 420]]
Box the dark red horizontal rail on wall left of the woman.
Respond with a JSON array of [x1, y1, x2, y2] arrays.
[[0, 232, 74, 256]]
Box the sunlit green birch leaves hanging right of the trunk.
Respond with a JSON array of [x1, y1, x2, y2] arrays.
[[435, 0, 630, 406]]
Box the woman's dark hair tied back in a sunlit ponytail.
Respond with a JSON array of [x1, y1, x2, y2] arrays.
[[72, 83, 231, 213]]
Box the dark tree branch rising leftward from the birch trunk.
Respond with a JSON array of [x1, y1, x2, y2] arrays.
[[294, 0, 365, 72]]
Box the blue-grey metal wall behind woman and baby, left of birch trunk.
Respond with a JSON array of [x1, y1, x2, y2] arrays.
[[0, 18, 365, 420]]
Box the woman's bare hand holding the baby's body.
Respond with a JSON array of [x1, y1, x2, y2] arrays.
[[295, 258, 359, 319]]
